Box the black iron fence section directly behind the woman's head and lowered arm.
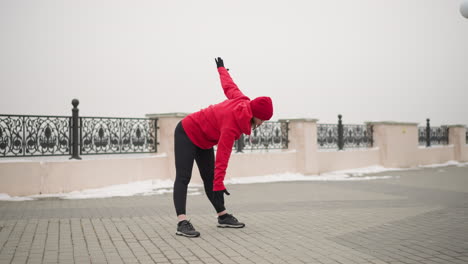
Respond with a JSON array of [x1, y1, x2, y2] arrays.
[[233, 121, 289, 152]]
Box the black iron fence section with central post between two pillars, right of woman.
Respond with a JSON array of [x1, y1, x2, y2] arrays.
[[317, 115, 373, 150]]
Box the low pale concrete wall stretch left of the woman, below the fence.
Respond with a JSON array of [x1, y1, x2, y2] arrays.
[[0, 155, 169, 195]]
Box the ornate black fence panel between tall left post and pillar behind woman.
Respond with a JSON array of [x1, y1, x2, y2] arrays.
[[80, 117, 157, 155]]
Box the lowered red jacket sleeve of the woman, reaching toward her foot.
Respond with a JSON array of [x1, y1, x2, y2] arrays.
[[213, 129, 236, 191]]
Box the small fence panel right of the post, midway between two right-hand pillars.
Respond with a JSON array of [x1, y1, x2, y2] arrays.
[[343, 125, 373, 148]]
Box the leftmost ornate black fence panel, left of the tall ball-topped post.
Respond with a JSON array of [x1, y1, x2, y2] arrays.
[[0, 115, 71, 157]]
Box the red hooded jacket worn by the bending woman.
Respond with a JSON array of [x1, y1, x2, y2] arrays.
[[182, 67, 253, 191]]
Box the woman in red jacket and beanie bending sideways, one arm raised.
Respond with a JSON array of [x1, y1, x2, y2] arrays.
[[174, 57, 273, 237]]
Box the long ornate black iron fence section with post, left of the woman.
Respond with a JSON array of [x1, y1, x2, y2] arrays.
[[0, 100, 158, 159]]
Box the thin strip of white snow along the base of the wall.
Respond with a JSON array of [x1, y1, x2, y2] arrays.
[[0, 161, 468, 201]]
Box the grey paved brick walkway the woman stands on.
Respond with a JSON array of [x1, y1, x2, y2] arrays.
[[0, 166, 468, 264]]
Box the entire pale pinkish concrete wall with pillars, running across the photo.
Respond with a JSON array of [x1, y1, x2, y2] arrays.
[[0, 113, 468, 196]]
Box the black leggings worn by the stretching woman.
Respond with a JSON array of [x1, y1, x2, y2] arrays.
[[174, 122, 226, 215]]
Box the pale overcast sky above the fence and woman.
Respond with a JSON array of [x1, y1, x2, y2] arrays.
[[0, 0, 468, 125]]
